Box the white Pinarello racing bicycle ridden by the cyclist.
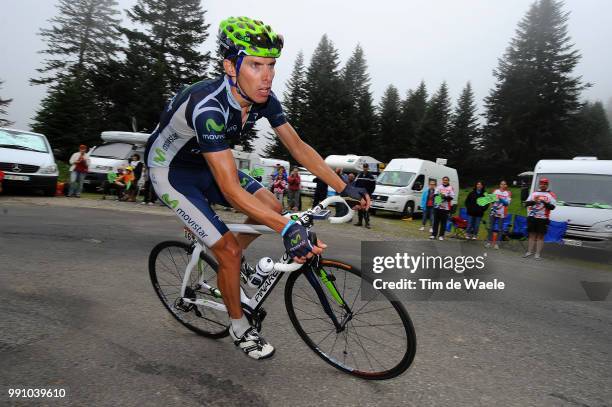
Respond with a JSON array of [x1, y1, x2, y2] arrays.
[[149, 196, 416, 380]]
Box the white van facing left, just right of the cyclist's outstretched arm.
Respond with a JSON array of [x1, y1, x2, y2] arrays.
[[372, 158, 459, 216]]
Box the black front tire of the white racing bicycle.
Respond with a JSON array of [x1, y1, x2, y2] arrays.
[[285, 259, 416, 380]]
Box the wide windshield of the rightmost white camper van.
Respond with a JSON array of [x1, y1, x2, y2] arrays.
[[536, 174, 612, 206]]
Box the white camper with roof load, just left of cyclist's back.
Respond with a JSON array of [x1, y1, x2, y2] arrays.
[[84, 131, 150, 187]]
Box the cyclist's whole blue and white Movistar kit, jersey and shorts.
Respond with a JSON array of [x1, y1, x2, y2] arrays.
[[145, 77, 287, 247]]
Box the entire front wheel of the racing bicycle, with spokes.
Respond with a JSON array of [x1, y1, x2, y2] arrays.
[[285, 260, 416, 380]]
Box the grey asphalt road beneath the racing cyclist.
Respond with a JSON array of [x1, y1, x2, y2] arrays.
[[0, 201, 612, 406]]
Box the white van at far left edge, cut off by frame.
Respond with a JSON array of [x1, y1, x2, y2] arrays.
[[0, 127, 59, 196]]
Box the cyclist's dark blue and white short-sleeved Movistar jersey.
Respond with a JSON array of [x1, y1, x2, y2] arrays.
[[145, 76, 287, 169]]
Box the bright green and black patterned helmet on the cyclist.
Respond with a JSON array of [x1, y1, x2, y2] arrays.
[[219, 17, 283, 58]]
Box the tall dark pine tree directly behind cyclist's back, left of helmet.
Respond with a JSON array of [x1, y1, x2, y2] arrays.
[[121, 0, 210, 131]]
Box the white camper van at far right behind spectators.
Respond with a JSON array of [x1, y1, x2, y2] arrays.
[[531, 157, 612, 247]]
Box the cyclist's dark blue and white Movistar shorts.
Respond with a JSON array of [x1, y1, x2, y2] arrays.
[[150, 167, 263, 247]]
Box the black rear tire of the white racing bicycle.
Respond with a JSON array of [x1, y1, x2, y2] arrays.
[[149, 240, 229, 339]]
